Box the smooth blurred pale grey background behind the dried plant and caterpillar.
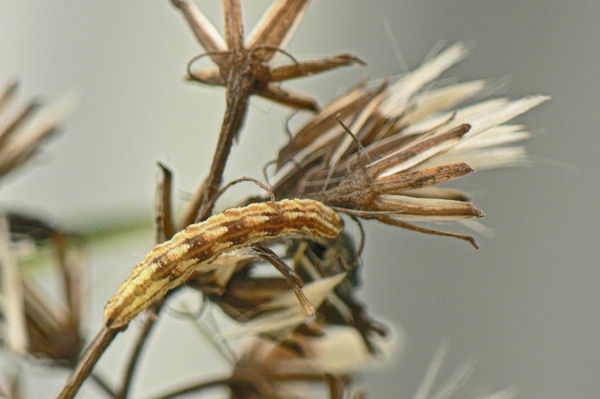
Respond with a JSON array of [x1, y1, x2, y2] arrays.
[[0, 0, 600, 399]]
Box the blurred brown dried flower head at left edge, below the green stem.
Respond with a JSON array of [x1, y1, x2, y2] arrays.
[[0, 218, 85, 366]]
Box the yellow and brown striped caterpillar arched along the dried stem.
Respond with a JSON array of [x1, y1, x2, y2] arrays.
[[104, 199, 344, 328]]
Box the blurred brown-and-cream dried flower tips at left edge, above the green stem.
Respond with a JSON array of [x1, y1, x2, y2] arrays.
[[0, 81, 75, 178]]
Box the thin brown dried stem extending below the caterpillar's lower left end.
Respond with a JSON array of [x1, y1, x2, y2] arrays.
[[57, 327, 121, 399]]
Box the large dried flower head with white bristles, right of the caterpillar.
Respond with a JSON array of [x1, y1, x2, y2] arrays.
[[272, 43, 548, 250]]
